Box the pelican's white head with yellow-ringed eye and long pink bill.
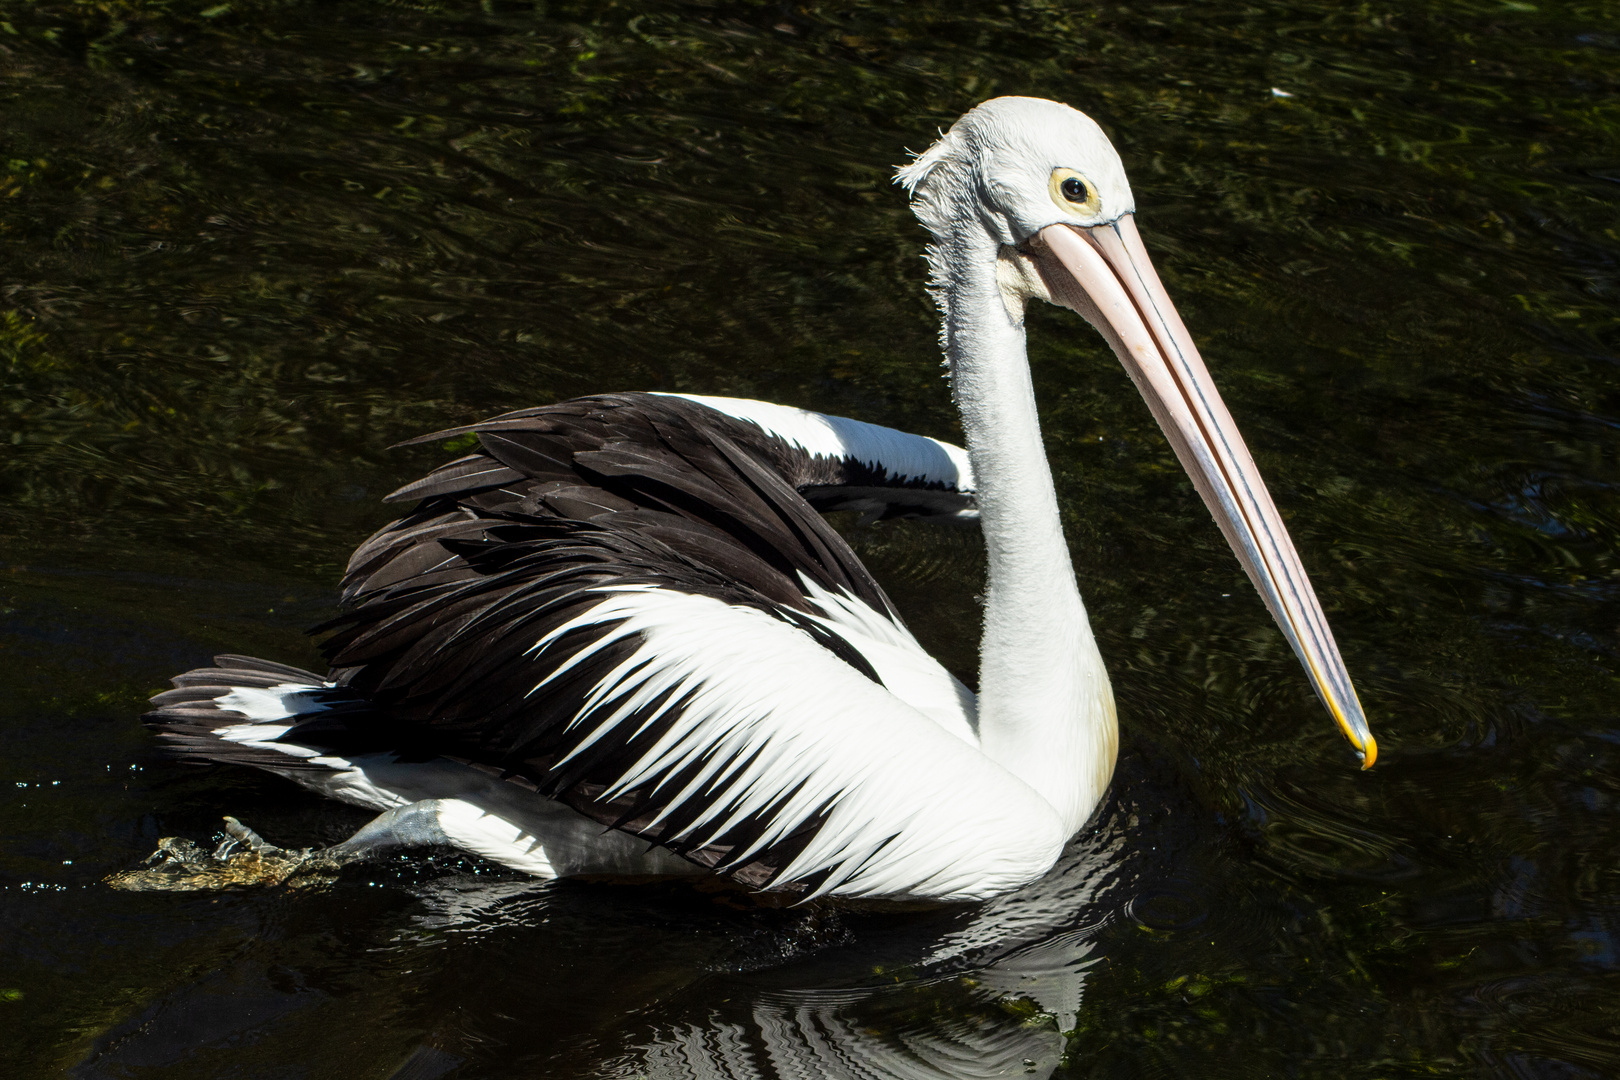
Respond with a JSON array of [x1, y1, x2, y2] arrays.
[[897, 97, 1379, 767]]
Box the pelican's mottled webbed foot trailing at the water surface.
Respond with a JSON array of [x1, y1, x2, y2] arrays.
[[105, 818, 352, 892]]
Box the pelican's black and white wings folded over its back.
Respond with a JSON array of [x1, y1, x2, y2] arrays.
[[284, 395, 1063, 897]]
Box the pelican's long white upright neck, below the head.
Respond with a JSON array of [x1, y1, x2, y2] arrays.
[[932, 222, 1118, 831]]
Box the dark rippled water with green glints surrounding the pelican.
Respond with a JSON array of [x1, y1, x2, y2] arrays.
[[0, 0, 1620, 1080]]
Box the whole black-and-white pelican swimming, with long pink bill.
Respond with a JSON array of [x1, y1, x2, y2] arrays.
[[125, 97, 1377, 902]]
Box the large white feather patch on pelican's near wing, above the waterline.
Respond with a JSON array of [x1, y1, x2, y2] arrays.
[[530, 585, 1066, 900]]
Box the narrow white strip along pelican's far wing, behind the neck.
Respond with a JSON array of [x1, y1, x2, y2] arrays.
[[658, 393, 974, 494]]
